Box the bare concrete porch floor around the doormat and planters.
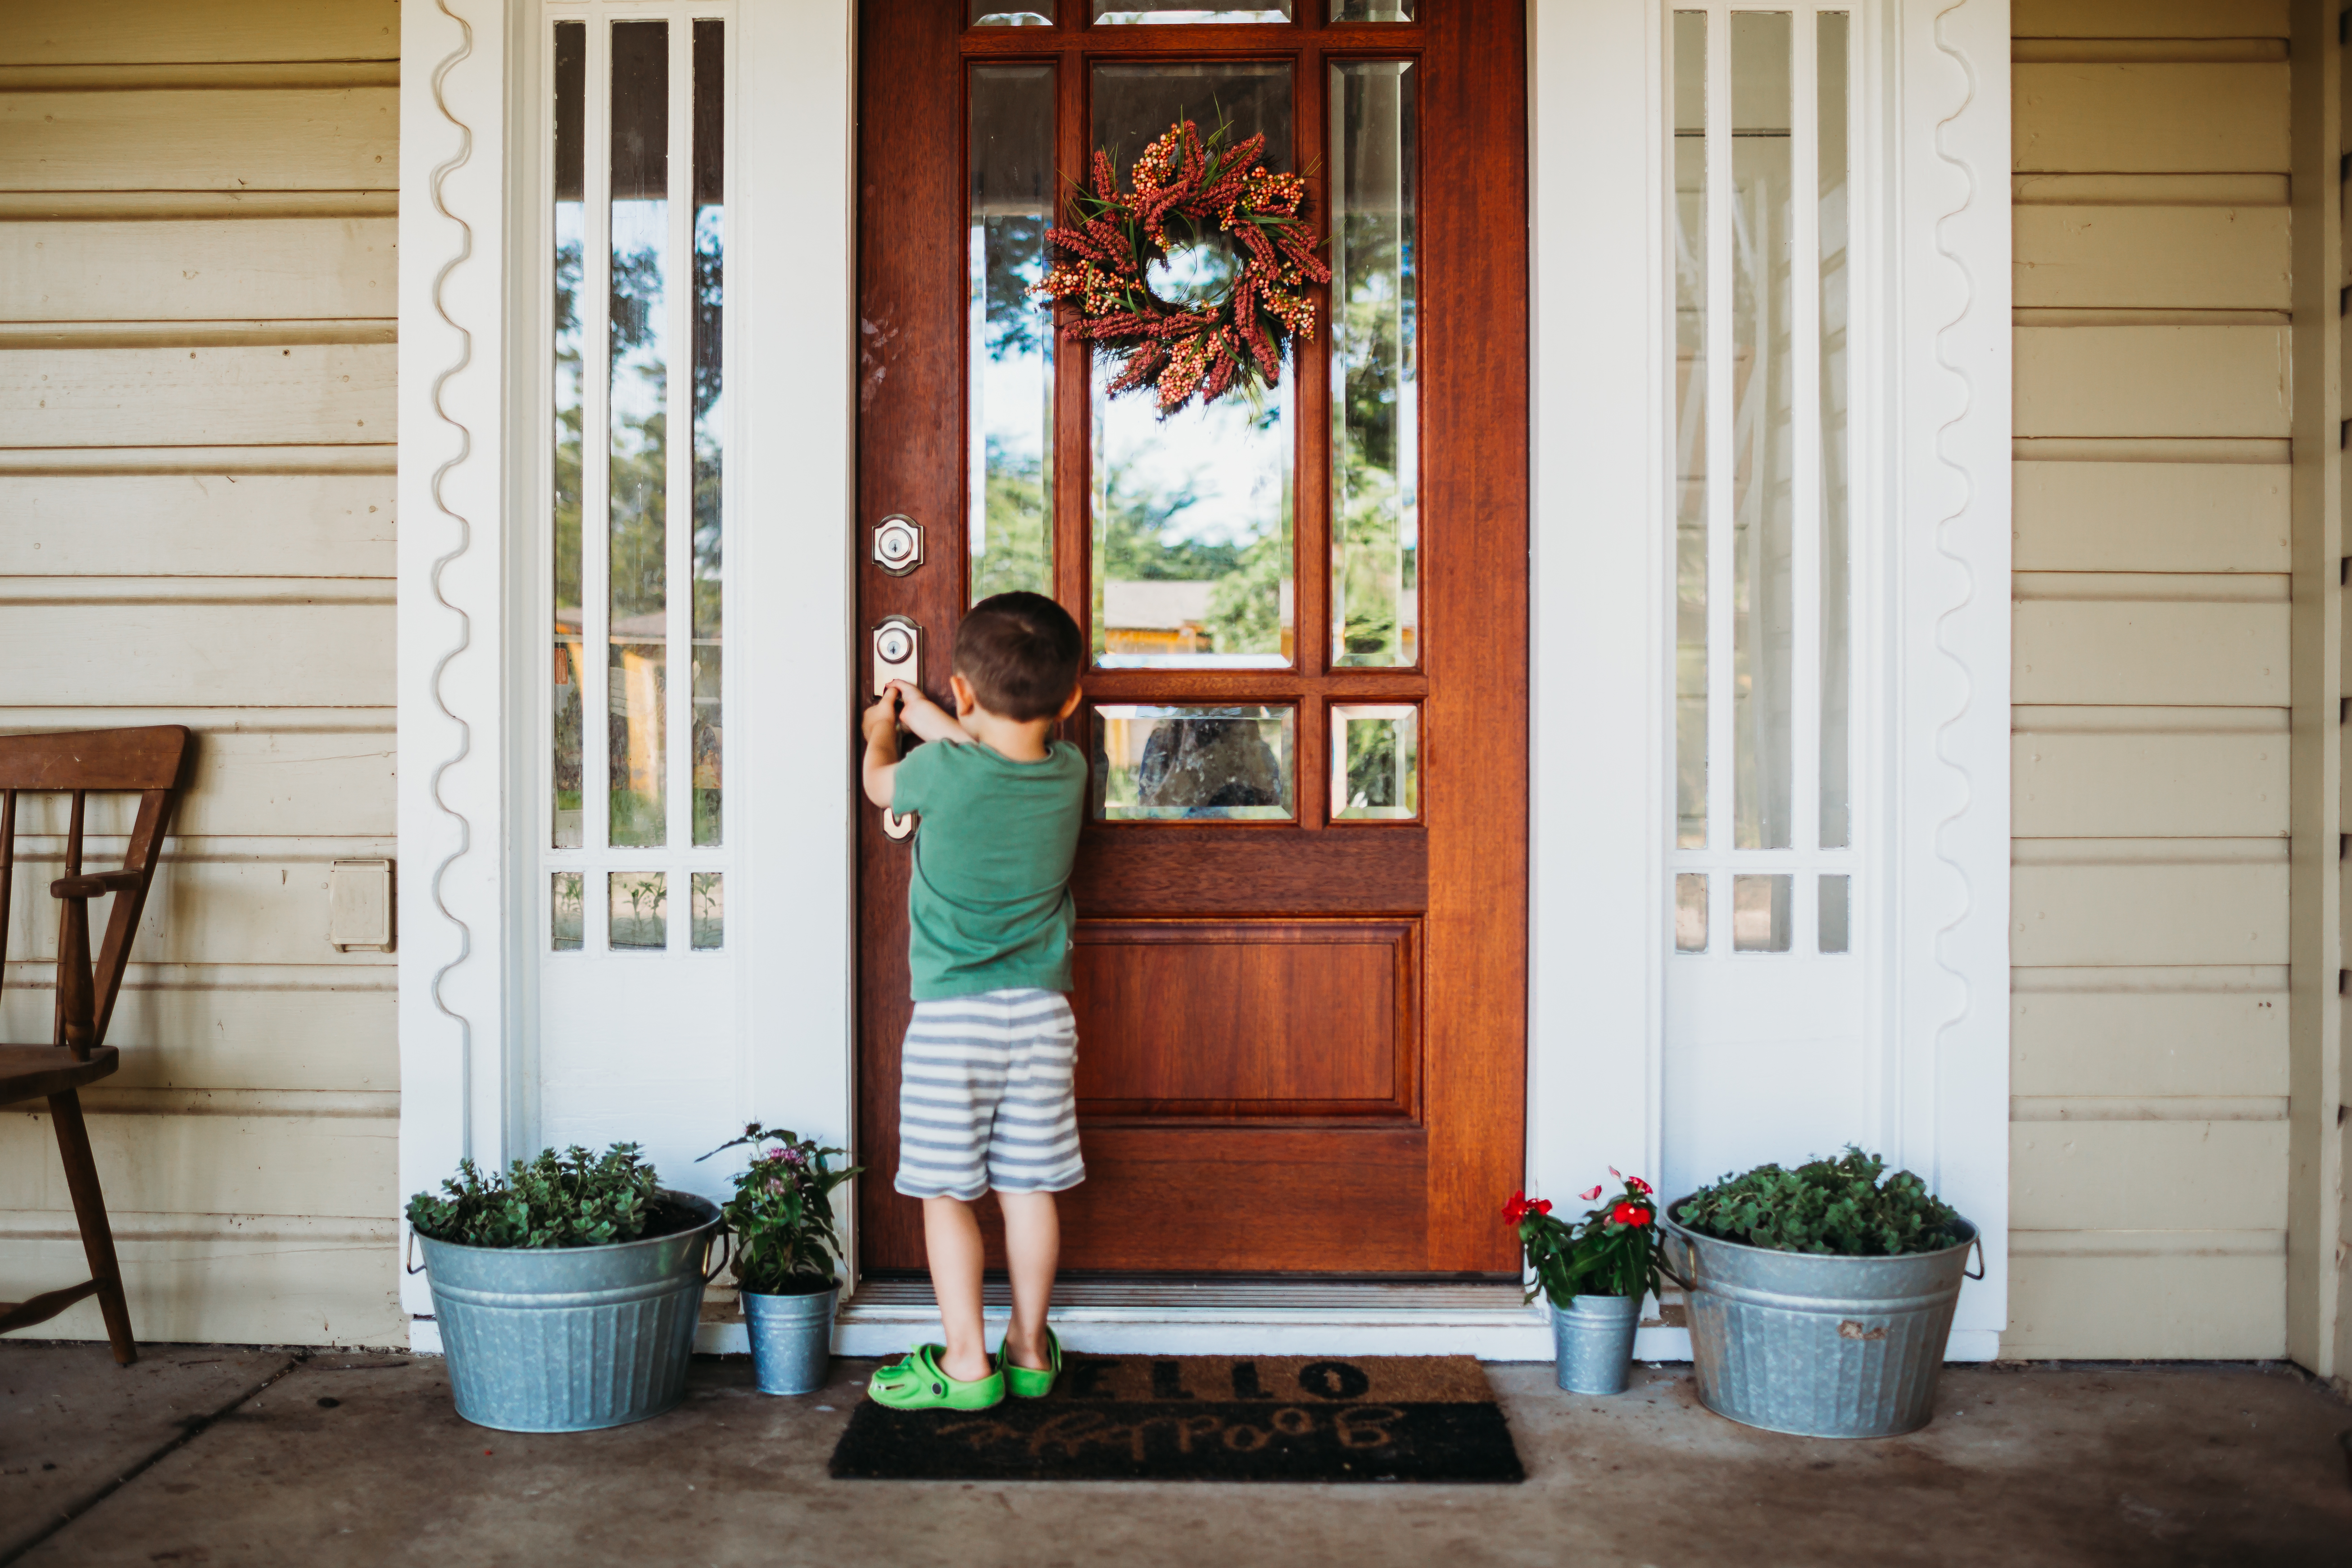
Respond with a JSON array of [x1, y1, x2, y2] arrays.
[[0, 1342, 2352, 1568]]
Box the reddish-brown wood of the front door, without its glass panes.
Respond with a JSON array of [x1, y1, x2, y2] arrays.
[[852, 0, 1529, 1277]]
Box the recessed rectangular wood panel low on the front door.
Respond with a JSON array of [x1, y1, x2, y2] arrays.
[[1070, 921, 1418, 1117]]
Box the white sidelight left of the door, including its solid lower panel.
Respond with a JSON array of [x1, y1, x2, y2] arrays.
[[534, 0, 739, 1178]]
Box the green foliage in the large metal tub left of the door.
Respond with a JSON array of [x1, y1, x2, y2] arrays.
[[409, 1142, 661, 1246]]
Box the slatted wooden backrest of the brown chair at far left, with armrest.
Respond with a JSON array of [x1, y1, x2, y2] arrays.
[[0, 724, 190, 1056]]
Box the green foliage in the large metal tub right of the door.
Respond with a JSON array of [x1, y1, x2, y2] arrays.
[[1675, 1145, 1962, 1258]]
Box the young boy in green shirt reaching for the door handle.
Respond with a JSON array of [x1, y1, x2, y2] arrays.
[[863, 593, 1087, 1410]]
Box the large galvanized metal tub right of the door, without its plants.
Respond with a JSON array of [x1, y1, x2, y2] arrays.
[[1660, 1206, 1983, 1437]]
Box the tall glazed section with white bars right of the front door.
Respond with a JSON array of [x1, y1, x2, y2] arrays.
[[1668, 5, 1860, 957]]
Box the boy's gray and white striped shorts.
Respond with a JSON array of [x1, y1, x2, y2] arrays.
[[894, 988, 1087, 1201]]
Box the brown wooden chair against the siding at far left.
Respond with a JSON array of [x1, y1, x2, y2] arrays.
[[0, 724, 188, 1366]]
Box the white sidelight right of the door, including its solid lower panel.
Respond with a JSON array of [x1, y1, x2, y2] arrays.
[[1660, 5, 1881, 1185]]
